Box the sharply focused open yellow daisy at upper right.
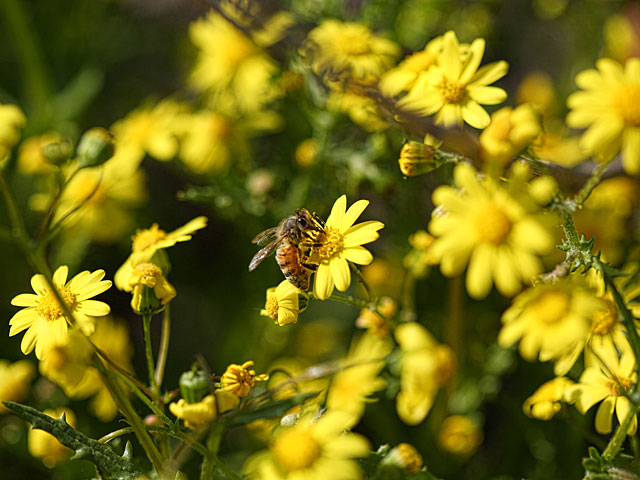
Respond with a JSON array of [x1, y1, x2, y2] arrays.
[[399, 31, 508, 128]]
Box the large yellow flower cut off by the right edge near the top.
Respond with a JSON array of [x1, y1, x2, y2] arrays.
[[567, 58, 640, 174]]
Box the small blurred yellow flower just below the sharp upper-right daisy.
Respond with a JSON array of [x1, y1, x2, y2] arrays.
[[480, 104, 540, 165]]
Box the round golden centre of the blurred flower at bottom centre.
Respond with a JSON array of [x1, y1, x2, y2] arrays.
[[271, 427, 321, 472]]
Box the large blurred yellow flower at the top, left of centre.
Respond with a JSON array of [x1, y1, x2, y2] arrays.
[[189, 11, 282, 113]]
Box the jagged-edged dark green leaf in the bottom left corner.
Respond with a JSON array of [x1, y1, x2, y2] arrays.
[[2, 402, 142, 480]]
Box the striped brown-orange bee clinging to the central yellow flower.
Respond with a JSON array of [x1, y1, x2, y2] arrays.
[[249, 208, 325, 291]]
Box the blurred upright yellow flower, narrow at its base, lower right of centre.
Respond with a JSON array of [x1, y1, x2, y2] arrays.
[[395, 322, 457, 425]]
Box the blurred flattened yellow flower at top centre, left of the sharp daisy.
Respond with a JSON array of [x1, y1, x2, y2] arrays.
[[301, 19, 400, 79]]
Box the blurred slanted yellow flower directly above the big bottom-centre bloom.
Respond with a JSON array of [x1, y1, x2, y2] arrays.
[[327, 333, 393, 419]]
